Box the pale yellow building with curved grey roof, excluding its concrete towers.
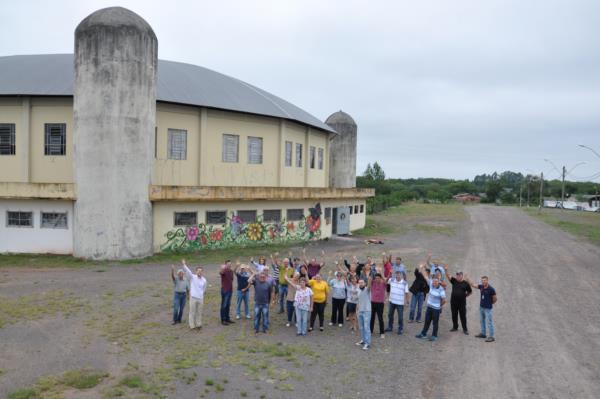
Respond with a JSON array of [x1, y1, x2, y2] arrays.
[[0, 54, 374, 253]]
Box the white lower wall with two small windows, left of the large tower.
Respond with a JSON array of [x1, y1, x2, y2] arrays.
[[0, 199, 73, 254]]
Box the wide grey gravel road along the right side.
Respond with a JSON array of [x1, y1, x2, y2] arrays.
[[431, 206, 600, 398]]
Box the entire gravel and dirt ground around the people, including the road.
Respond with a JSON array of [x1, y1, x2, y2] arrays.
[[0, 206, 600, 398]]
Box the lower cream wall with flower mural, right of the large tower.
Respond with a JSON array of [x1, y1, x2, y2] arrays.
[[153, 199, 366, 252]]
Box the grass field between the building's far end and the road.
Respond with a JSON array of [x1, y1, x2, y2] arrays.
[[354, 202, 466, 237]]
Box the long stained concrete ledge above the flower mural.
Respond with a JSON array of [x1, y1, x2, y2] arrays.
[[150, 186, 375, 201]]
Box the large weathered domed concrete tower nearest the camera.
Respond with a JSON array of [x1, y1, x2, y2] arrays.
[[73, 7, 158, 259]]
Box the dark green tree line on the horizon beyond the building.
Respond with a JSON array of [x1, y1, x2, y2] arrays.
[[356, 162, 600, 213]]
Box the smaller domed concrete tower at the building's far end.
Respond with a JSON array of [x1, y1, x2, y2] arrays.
[[325, 111, 358, 188]]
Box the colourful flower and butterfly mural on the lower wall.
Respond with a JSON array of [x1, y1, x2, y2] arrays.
[[160, 203, 321, 251]]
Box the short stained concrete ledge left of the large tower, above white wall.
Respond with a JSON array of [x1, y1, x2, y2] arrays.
[[0, 182, 75, 201]]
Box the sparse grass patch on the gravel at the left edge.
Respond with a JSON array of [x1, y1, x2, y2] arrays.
[[0, 290, 87, 328]]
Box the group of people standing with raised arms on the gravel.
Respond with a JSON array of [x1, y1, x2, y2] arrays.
[[171, 250, 497, 350]]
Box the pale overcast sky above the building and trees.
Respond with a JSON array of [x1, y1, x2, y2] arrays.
[[0, 0, 600, 182]]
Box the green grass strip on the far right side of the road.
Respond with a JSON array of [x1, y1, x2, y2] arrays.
[[523, 208, 600, 245]]
